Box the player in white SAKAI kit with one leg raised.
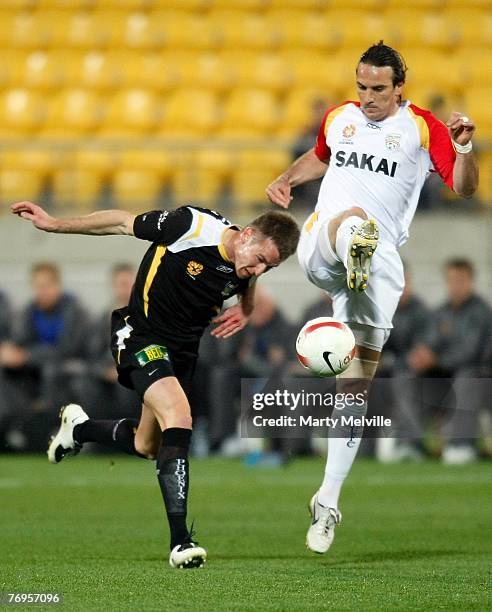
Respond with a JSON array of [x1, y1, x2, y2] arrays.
[[267, 41, 478, 553]]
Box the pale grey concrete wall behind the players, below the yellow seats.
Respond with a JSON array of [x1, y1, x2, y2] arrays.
[[0, 213, 492, 321]]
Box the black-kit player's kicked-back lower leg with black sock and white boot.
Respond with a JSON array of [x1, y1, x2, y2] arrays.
[[48, 404, 145, 463]]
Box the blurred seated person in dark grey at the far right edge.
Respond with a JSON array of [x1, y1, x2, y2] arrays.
[[399, 259, 492, 463]]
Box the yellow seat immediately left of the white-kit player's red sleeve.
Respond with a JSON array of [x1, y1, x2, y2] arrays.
[[278, 88, 330, 138]]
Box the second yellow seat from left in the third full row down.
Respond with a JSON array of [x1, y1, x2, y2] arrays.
[[41, 89, 103, 139]]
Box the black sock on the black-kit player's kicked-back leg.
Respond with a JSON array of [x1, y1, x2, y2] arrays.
[[73, 419, 145, 459]]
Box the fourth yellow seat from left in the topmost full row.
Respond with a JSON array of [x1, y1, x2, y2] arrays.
[[150, 10, 220, 51]]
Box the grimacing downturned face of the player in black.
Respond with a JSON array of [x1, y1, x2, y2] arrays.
[[234, 227, 280, 278]]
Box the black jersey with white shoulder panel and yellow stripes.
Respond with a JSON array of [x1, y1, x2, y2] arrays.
[[129, 206, 249, 344]]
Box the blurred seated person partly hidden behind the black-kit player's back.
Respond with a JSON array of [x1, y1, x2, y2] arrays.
[[82, 263, 141, 426]]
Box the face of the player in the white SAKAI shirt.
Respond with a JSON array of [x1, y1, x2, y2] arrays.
[[356, 63, 403, 121]]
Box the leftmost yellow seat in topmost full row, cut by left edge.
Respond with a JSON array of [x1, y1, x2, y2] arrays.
[[0, 11, 50, 49]]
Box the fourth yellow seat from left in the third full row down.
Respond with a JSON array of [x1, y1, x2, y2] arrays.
[[159, 89, 219, 138]]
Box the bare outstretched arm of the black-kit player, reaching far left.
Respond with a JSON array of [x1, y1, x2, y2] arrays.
[[11, 202, 135, 236]]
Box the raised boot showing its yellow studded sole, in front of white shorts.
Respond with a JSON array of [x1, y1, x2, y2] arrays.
[[347, 219, 379, 293]]
